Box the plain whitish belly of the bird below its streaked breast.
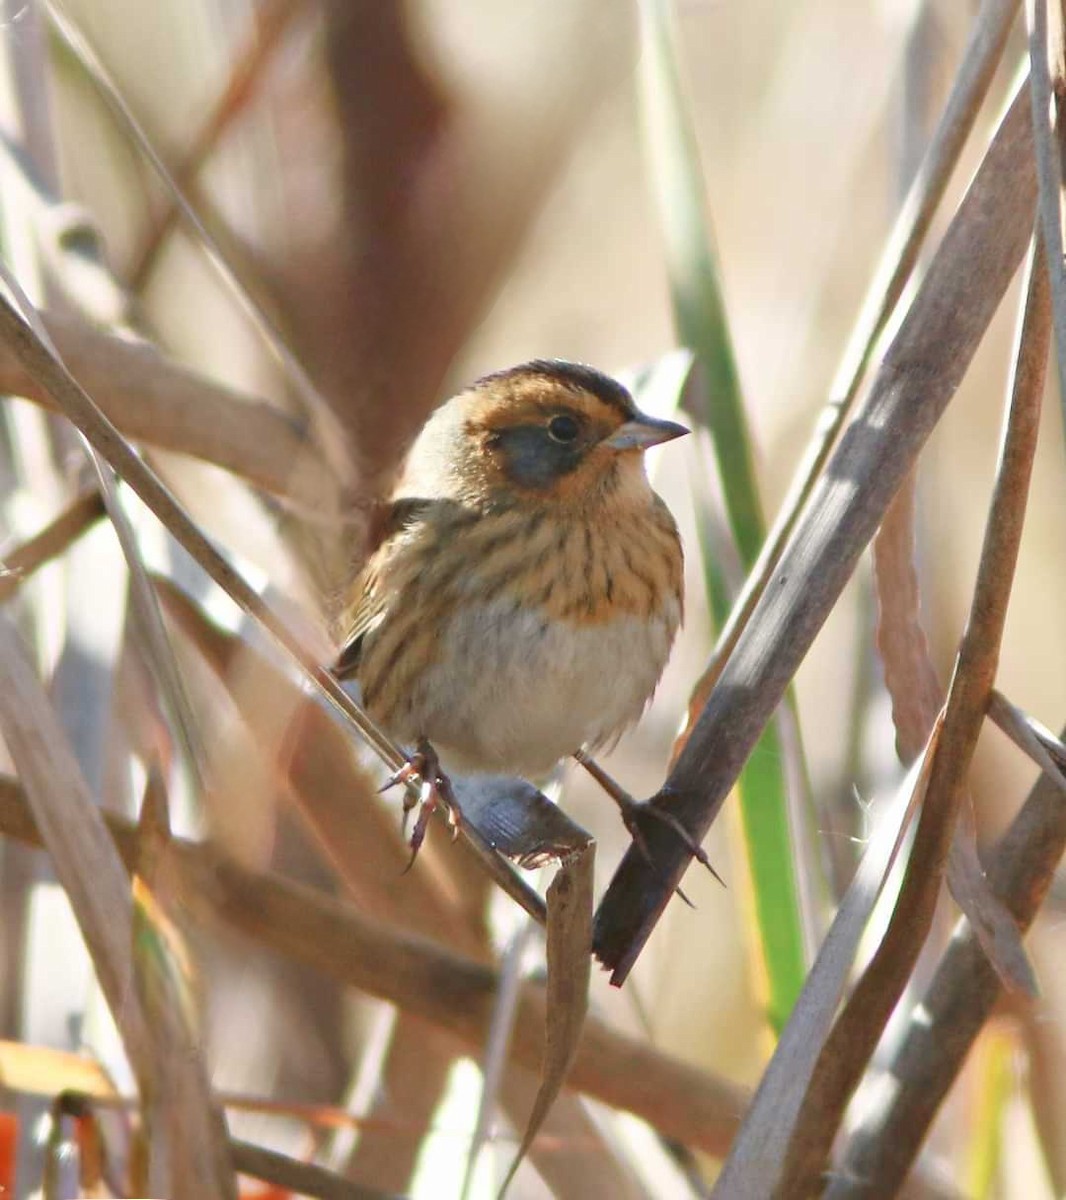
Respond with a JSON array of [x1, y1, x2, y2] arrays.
[[409, 599, 681, 779]]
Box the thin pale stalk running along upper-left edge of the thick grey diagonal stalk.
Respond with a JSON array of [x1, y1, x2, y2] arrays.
[[673, 0, 1019, 757]]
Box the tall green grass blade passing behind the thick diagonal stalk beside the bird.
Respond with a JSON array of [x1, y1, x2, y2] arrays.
[[640, 0, 806, 1030]]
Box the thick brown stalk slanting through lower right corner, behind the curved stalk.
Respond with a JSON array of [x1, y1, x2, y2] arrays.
[[827, 732, 1066, 1200]]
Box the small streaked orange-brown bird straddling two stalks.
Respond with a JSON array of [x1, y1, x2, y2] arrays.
[[334, 359, 702, 862]]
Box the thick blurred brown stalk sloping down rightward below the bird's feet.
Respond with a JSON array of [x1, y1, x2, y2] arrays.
[[0, 775, 748, 1156]]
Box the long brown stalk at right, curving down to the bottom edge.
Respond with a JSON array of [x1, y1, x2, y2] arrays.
[[778, 236, 1050, 1196]]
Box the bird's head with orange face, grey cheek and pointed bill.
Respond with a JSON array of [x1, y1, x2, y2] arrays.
[[408, 360, 688, 505]]
